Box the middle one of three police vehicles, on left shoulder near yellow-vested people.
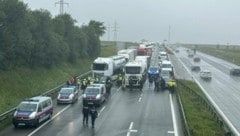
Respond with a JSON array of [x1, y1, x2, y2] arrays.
[[57, 86, 79, 104]]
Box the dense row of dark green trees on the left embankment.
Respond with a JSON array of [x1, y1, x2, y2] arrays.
[[0, 0, 106, 70]]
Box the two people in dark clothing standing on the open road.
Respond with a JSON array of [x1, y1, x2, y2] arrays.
[[82, 105, 98, 128]]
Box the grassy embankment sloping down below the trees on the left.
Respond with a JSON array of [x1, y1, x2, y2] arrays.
[[0, 42, 116, 128]]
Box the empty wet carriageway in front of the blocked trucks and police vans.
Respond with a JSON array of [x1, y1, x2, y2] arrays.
[[0, 45, 183, 136]]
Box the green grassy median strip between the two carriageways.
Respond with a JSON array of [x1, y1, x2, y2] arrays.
[[179, 80, 224, 136]]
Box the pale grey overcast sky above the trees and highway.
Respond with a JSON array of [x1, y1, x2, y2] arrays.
[[23, 0, 240, 44]]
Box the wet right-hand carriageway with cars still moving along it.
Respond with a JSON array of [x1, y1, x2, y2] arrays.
[[172, 48, 240, 135]]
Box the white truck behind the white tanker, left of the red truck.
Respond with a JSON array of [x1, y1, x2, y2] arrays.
[[117, 49, 137, 62]]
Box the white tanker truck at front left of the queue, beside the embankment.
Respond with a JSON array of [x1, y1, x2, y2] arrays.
[[92, 55, 126, 77]]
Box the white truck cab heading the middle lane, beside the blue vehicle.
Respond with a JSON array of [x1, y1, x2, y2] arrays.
[[123, 61, 147, 88]]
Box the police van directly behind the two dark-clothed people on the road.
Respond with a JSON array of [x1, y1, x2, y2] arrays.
[[83, 84, 107, 106]]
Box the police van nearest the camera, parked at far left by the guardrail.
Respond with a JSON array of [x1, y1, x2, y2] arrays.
[[13, 96, 53, 128]]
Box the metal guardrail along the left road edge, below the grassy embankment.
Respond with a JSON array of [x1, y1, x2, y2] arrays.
[[0, 71, 91, 122]]
